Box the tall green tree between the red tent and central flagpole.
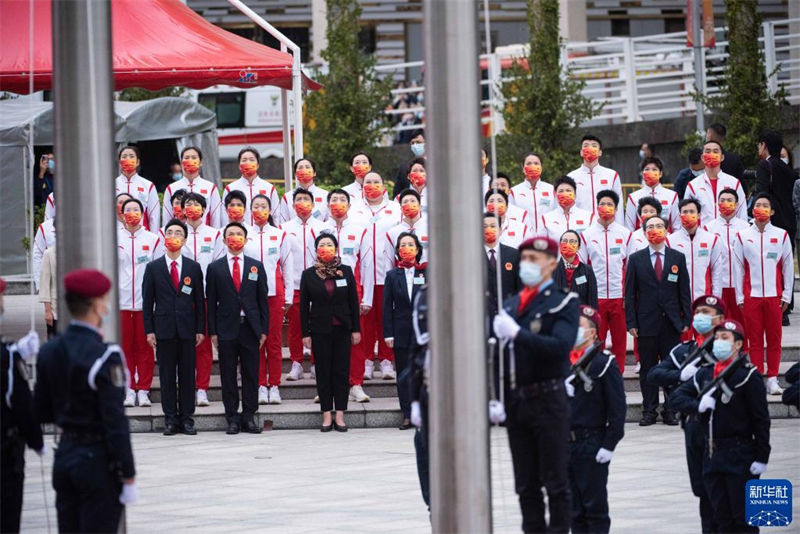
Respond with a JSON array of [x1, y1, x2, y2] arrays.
[[305, 0, 391, 184]]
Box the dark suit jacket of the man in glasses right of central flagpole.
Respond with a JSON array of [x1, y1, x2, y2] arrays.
[[625, 247, 692, 336]]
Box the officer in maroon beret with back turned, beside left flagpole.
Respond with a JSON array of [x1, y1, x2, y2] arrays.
[[35, 269, 137, 532]]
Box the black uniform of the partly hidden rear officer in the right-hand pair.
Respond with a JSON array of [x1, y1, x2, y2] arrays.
[[647, 339, 719, 533]]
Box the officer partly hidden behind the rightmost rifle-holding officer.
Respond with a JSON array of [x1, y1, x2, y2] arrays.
[[647, 295, 725, 532]]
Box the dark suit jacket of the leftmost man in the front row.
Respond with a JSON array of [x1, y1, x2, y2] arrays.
[[142, 256, 206, 339]]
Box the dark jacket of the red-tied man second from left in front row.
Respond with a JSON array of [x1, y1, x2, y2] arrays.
[[206, 253, 269, 340]]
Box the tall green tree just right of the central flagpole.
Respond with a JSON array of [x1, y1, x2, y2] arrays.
[[497, 0, 602, 180]]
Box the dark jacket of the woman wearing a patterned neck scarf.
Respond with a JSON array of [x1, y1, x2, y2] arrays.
[[300, 265, 361, 337]]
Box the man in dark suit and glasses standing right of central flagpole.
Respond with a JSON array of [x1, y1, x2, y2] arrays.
[[625, 215, 692, 426]]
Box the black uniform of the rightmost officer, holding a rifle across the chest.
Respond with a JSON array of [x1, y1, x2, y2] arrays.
[[669, 358, 770, 533]]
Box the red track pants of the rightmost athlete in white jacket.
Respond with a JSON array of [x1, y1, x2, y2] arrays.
[[742, 297, 783, 378]]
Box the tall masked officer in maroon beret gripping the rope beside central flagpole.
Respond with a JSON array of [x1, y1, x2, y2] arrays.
[[494, 237, 578, 532]]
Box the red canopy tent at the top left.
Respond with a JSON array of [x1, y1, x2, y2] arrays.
[[0, 0, 320, 93]]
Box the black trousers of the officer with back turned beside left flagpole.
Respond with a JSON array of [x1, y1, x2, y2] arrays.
[[53, 439, 122, 532]]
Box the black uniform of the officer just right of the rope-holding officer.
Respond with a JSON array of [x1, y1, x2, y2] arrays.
[[569, 344, 628, 533]]
